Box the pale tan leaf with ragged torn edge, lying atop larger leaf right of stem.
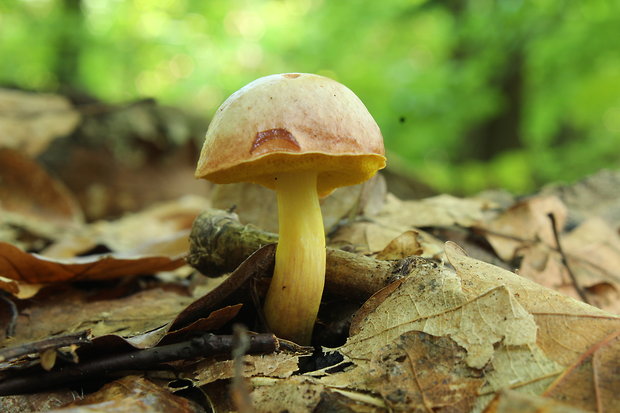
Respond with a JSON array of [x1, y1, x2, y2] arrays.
[[339, 251, 536, 368]]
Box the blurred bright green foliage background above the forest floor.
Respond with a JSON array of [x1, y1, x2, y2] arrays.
[[0, 0, 620, 193]]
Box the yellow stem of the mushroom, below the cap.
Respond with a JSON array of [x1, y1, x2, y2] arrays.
[[264, 171, 325, 345]]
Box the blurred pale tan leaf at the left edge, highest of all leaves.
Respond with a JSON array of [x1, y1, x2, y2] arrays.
[[0, 89, 80, 156]]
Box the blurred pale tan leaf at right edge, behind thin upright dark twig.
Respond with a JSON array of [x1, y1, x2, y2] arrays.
[[482, 196, 620, 312]]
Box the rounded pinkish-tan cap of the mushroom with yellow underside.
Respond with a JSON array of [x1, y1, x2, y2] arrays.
[[195, 73, 385, 196]]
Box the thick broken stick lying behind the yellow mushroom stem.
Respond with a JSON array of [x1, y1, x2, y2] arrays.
[[187, 209, 437, 298]]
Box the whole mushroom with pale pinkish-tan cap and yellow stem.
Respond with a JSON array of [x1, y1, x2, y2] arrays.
[[195, 73, 385, 344]]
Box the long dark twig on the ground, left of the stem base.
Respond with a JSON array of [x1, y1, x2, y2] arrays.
[[0, 334, 279, 396]]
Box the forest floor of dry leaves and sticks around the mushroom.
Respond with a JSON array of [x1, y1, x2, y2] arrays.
[[0, 90, 620, 412]]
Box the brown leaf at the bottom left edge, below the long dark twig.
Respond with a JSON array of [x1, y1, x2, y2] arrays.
[[53, 376, 203, 413]]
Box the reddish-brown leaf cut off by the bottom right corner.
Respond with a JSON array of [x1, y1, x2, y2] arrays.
[[544, 330, 620, 412]]
